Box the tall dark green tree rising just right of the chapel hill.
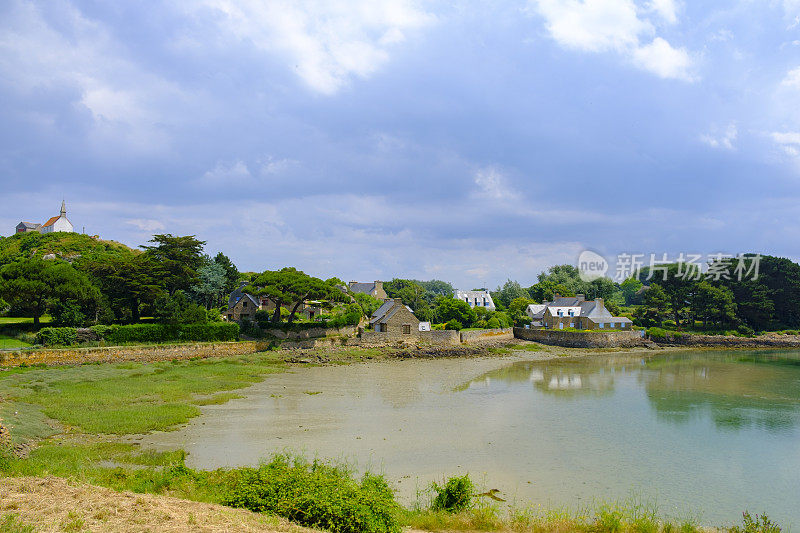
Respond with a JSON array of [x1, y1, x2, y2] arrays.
[[142, 233, 206, 294]]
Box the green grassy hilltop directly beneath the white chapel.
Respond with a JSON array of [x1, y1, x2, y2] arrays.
[[0, 232, 141, 265]]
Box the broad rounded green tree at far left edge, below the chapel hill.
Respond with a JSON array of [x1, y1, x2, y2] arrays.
[[0, 258, 100, 326]]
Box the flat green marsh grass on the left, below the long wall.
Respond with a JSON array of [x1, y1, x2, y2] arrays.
[[0, 354, 284, 438]]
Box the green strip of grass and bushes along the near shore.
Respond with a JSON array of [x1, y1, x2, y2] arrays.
[[0, 436, 756, 533]]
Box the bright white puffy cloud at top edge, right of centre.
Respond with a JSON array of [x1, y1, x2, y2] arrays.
[[531, 0, 694, 81]]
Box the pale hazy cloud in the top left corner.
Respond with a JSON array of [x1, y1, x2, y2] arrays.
[[0, 0, 189, 153]]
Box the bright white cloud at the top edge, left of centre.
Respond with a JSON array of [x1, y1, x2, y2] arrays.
[[195, 0, 434, 94]]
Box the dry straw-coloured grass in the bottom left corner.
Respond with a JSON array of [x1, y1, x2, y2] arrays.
[[0, 477, 314, 533]]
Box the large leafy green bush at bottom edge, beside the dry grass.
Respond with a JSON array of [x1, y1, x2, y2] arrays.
[[223, 455, 400, 533]]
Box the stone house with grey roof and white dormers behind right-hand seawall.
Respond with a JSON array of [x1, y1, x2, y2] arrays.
[[526, 294, 633, 330]]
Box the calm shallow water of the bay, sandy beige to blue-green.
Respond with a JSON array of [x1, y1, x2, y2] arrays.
[[143, 351, 800, 530]]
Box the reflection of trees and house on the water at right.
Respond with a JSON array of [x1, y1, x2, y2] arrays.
[[456, 351, 800, 432]]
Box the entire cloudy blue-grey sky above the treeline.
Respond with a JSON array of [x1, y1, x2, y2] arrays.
[[0, 0, 800, 288]]
